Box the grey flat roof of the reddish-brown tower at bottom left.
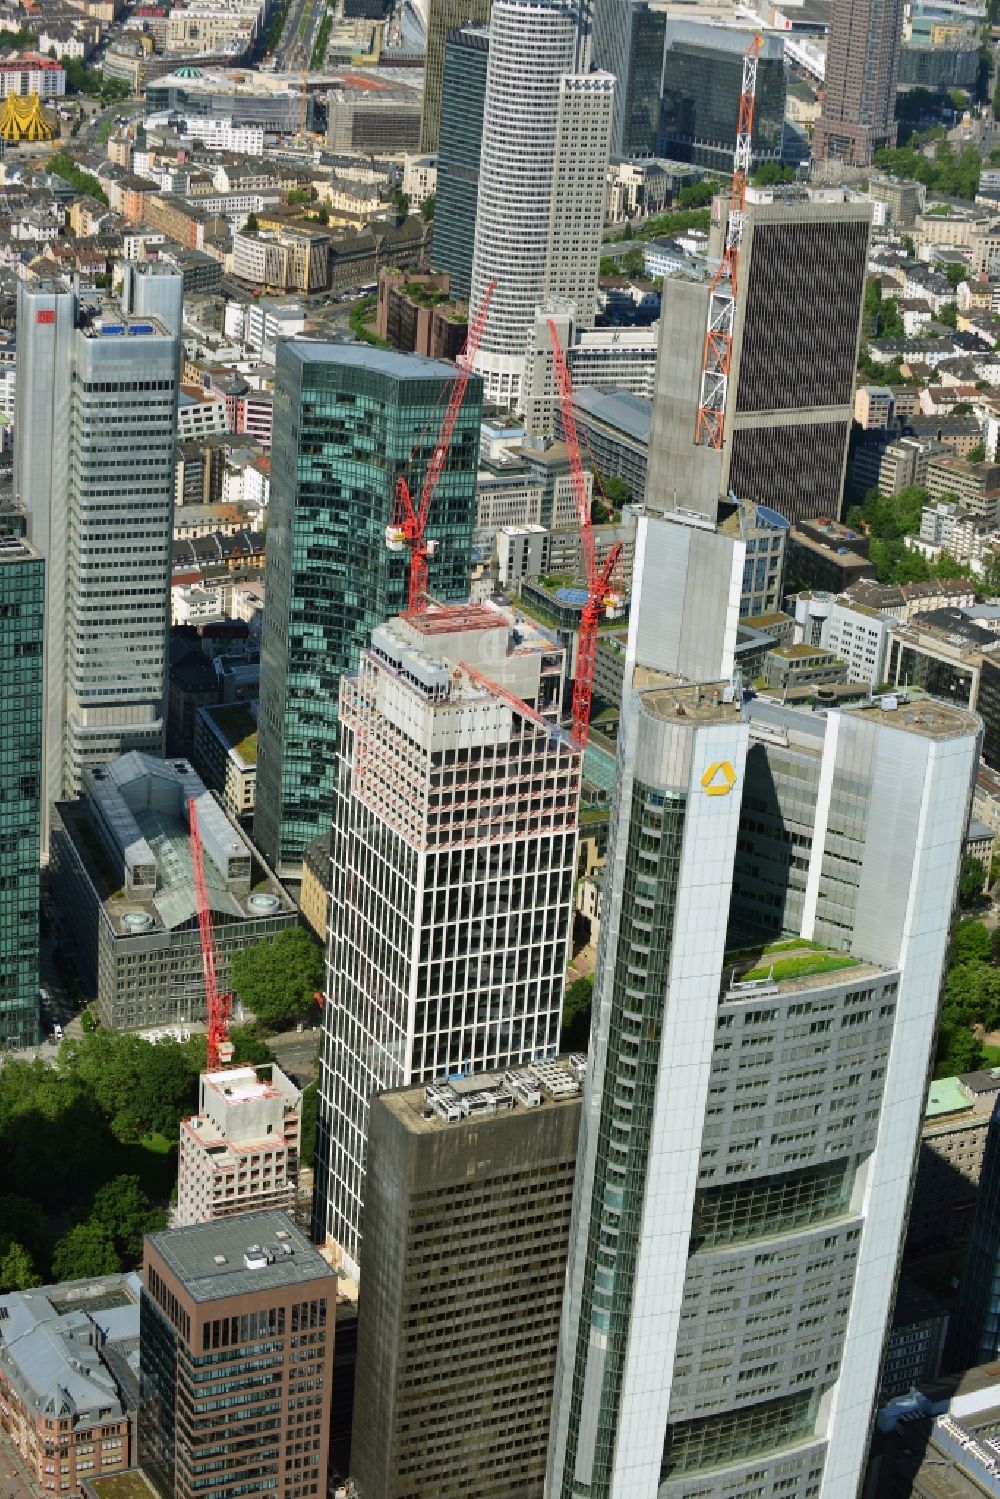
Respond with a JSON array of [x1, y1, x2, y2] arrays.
[[148, 1211, 337, 1301]]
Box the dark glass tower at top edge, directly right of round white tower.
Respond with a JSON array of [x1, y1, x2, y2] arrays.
[[591, 0, 667, 156]]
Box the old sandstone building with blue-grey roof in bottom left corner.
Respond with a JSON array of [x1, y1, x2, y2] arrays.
[[0, 1276, 139, 1499]]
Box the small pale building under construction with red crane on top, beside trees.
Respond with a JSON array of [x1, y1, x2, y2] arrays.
[[174, 1063, 301, 1228]]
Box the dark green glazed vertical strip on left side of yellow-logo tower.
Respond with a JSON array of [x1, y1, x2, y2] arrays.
[[561, 781, 687, 1499]]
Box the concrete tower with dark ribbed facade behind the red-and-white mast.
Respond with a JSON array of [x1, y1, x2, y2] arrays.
[[646, 192, 871, 522]]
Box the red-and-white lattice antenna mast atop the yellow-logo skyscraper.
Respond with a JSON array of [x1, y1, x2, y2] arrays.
[[694, 34, 763, 448]]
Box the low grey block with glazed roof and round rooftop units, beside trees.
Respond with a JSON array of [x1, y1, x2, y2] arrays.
[[52, 751, 295, 1030]]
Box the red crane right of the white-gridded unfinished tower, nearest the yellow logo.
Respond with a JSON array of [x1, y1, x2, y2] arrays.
[[549, 318, 622, 750]]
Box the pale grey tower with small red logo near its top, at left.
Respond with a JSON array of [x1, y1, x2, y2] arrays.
[[15, 277, 180, 856]]
